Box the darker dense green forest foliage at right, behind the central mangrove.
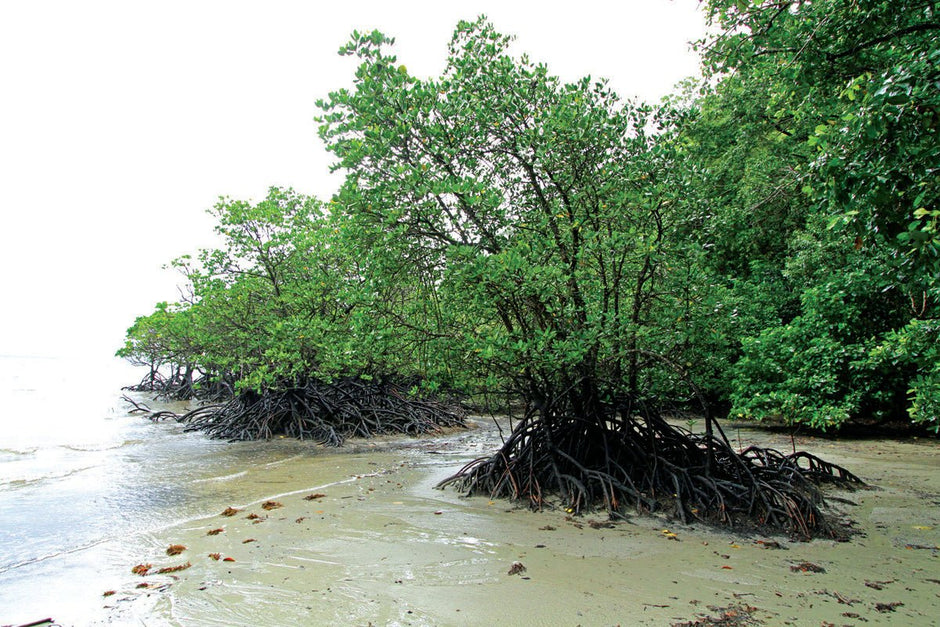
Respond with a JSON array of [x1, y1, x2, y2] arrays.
[[691, 0, 940, 429]]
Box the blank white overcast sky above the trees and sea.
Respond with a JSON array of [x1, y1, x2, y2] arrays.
[[0, 0, 704, 358]]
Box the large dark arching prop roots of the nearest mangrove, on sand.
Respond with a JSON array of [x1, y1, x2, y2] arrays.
[[438, 411, 863, 538]]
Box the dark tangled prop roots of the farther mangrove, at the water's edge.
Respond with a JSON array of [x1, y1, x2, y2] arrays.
[[151, 378, 464, 446]]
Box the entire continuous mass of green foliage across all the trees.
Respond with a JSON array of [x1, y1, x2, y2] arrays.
[[119, 0, 940, 440]]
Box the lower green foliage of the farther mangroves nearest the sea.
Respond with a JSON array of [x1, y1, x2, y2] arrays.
[[118, 189, 444, 390]]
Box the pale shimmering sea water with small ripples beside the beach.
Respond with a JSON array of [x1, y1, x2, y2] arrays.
[[0, 356, 320, 625]]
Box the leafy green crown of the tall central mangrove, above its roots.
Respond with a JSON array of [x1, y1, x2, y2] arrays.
[[321, 22, 704, 420]]
